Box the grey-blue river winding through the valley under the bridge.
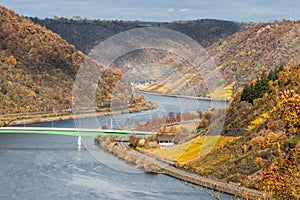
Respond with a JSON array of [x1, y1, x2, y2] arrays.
[[0, 95, 232, 200]]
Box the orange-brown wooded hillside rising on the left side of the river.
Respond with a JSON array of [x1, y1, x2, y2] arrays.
[[0, 7, 145, 117]]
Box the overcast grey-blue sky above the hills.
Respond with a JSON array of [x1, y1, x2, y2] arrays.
[[0, 0, 300, 22]]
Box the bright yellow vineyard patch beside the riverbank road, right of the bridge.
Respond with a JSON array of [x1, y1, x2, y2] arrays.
[[152, 136, 234, 164]]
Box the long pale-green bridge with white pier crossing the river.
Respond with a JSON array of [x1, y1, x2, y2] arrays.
[[0, 127, 157, 146]]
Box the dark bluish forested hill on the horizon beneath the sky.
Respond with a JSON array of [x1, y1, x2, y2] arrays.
[[30, 18, 240, 54]]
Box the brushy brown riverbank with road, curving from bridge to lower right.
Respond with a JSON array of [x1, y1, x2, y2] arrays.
[[95, 136, 264, 199]]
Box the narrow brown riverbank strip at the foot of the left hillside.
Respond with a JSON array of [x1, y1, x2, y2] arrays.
[[0, 102, 158, 127]]
